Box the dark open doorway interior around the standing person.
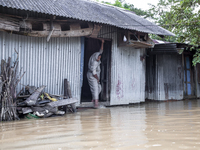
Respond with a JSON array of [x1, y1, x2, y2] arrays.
[[81, 38, 112, 102]]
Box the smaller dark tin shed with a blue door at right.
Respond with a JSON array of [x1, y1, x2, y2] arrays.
[[146, 40, 200, 101]]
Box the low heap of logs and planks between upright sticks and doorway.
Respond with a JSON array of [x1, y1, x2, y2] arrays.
[[17, 86, 77, 118]]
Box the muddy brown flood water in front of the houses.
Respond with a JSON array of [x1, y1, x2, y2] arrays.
[[0, 100, 200, 150]]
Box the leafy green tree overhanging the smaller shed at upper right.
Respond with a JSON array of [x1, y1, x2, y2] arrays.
[[148, 0, 200, 65]]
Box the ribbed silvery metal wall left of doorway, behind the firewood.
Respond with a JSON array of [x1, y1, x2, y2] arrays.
[[0, 32, 81, 103]]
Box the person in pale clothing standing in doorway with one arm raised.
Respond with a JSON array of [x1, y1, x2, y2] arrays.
[[87, 40, 104, 108]]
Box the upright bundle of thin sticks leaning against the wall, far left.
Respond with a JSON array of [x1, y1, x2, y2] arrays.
[[0, 53, 25, 121]]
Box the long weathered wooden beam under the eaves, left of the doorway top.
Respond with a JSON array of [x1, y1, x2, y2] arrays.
[[0, 15, 97, 37]]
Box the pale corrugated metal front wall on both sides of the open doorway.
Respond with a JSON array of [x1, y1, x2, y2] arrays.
[[0, 26, 146, 105]]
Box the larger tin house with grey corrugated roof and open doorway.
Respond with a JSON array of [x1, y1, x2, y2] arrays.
[[0, 0, 174, 105]]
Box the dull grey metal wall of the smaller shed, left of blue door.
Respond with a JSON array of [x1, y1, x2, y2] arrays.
[[146, 53, 184, 100]]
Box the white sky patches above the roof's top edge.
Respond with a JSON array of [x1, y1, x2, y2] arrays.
[[103, 0, 159, 10]]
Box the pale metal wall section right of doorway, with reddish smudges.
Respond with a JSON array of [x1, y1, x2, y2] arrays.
[[99, 27, 146, 105]]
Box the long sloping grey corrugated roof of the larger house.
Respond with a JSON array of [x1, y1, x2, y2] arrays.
[[0, 0, 174, 36]]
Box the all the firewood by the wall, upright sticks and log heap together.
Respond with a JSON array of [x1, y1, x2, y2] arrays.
[[0, 52, 77, 121]]
